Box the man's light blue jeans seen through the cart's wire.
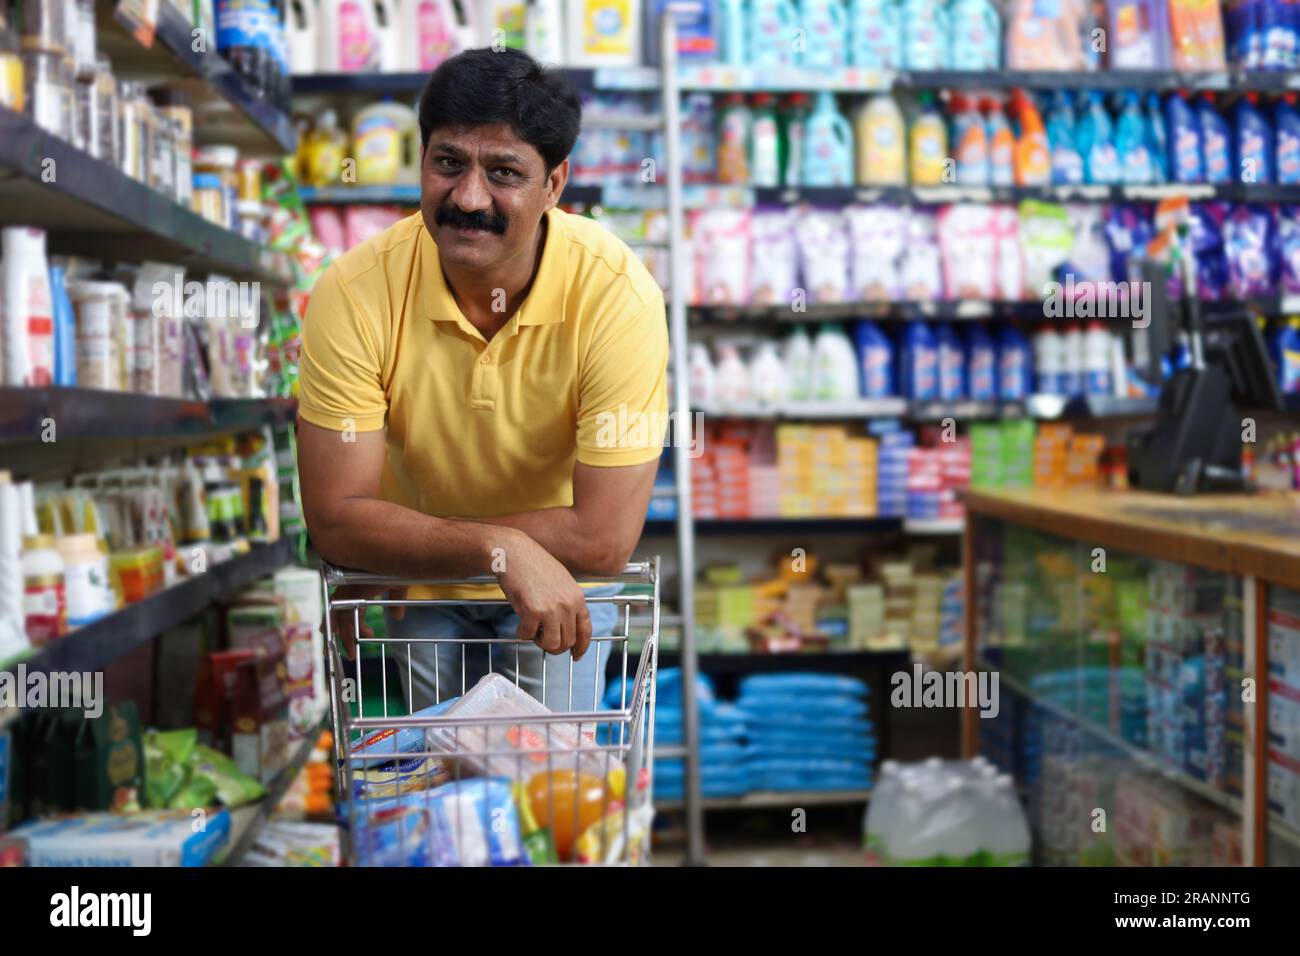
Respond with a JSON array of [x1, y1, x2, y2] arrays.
[[387, 584, 623, 713]]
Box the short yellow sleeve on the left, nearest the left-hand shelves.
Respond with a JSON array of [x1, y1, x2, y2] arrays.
[[298, 265, 387, 432]]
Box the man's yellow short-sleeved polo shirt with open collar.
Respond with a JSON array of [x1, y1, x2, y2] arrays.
[[298, 209, 668, 593]]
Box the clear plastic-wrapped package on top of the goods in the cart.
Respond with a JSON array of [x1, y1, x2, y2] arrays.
[[428, 674, 625, 779]]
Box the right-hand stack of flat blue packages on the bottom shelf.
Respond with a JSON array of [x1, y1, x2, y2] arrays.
[[736, 674, 876, 791]]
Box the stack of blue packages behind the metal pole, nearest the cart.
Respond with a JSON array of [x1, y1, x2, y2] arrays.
[[598, 667, 750, 801]]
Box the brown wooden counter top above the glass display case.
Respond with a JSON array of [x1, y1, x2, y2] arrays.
[[962, 488, 1300, 588]]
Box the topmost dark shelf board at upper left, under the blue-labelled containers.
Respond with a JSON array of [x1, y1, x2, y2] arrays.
[[98, 3, 298, 156]]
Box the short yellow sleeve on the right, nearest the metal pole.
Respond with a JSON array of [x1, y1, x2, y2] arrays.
[[577, 295, 668, 467]]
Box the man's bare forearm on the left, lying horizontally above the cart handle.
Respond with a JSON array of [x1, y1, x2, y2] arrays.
[[309, 498, 520, 578]]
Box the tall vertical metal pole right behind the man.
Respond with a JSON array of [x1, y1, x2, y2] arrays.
[[659, 5, 705, 866]]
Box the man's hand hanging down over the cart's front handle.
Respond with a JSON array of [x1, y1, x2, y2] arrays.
[[497, 535, 592, 661]]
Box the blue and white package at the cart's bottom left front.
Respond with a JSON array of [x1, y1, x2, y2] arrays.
[[355, 778, 527, 866]]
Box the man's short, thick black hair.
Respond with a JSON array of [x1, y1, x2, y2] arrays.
[[420, 47, 582, 173]]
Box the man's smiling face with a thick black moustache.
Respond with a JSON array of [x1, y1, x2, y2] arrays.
[[420, 124, 568, 271]]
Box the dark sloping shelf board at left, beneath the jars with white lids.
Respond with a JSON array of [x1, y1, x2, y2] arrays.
[[9, 538, 294, 674]]
